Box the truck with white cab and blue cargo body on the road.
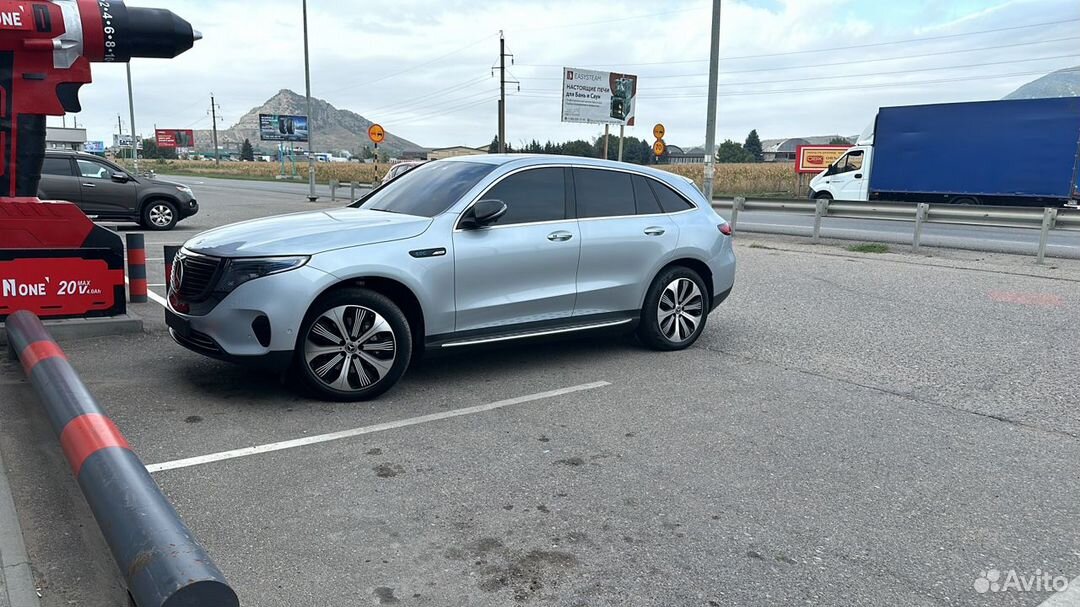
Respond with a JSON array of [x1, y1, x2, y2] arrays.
[[810, 97, 1080, 206]]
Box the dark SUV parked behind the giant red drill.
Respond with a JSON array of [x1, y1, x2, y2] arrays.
[[38, 150, 199, 230]]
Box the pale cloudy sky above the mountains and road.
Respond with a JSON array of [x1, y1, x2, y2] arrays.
[[56, 0, 1080, 147]]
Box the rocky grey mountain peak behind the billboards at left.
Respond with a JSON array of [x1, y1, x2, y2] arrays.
[[195, 89, 424, 157]]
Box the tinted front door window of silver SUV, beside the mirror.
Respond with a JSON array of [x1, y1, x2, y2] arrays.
[[483, 167, 566, 226]]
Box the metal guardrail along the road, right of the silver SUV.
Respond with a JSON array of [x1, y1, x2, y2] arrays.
[[713, 197, 1080, 264]]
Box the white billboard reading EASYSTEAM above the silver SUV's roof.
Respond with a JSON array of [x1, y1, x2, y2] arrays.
[[563, 67, 637, 126]]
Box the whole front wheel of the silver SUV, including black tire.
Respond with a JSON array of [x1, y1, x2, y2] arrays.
[[294, 288, 413, 401]]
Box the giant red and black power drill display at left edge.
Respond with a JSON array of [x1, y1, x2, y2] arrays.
[[0, 0, 201, 320]]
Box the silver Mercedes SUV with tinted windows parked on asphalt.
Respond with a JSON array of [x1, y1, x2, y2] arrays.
[[165, 154, 735, 401]]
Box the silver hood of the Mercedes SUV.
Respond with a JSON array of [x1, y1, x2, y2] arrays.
[[184, 208, 431, 257]]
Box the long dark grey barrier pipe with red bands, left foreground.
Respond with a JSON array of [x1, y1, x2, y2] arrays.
[[6, 310, 240, 607]]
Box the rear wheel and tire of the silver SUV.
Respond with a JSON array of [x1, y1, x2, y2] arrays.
[[637, 266, 710, 351]]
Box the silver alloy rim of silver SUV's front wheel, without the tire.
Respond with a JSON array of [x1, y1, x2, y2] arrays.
[[303, 306, 397, 392]]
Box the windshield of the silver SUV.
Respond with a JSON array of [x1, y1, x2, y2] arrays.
[[352, 162, 496, 217]]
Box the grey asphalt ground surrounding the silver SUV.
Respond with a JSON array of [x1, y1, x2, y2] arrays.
[[0, 179, 1080, 607]]
